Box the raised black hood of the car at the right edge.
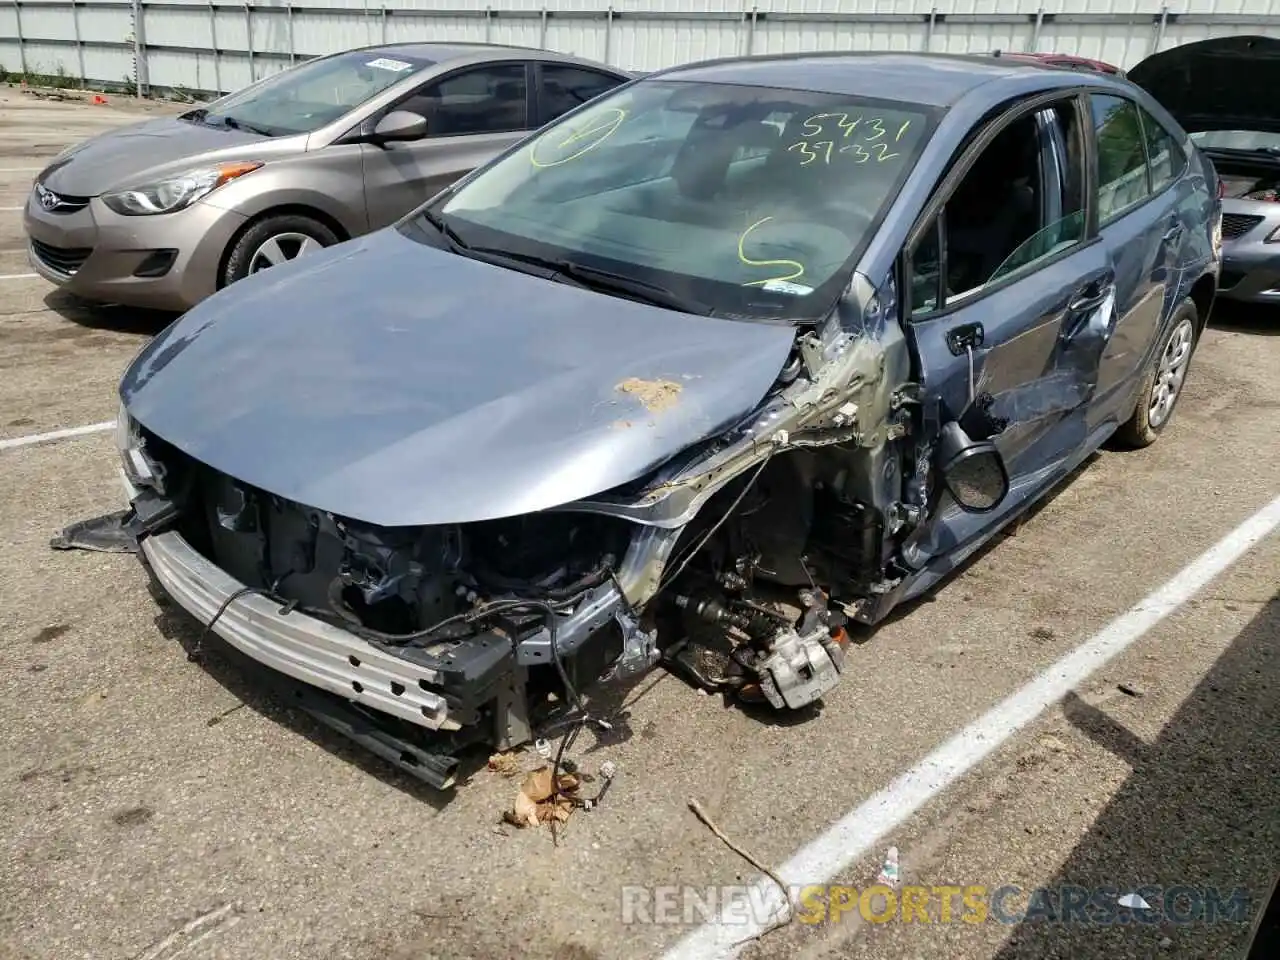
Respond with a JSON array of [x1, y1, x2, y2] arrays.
[[1128, 36, 1280, 133]]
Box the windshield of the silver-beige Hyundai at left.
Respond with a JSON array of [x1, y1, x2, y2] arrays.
[[184, 50, 431, 137]]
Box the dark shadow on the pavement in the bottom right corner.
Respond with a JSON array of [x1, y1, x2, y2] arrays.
[[992, 593, 1280, 960]]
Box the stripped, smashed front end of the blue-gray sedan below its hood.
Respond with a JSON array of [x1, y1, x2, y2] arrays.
[[102, 268, 1007, 787]]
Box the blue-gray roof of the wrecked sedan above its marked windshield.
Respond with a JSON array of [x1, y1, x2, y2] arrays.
[[648, 51, 1059, 108]]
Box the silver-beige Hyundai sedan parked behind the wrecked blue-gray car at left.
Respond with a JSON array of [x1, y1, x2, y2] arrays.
[[24, 44, 630, 310]]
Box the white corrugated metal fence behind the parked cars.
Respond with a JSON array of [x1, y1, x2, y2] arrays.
[[0, 0, 1280, 97]]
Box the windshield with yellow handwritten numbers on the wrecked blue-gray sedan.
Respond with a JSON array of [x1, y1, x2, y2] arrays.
[[410, 79, 937, 320]]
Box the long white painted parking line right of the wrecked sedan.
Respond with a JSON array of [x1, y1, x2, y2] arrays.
[[664, 497, 1280, 960]]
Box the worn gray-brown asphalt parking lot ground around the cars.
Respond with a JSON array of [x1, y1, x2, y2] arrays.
[[0, 90, 1280, 960]]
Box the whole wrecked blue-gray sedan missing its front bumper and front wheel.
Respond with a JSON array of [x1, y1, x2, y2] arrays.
[[102, 54, 1219, 787]]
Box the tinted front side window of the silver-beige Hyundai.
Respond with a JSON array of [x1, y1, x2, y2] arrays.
[[403, 63, 529, 137]]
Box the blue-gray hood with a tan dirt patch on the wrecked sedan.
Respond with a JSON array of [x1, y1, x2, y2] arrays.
[[120, 228, 795, 526]]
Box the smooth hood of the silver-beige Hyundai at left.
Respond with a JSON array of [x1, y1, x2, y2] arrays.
[[36, 116, 269, 197]]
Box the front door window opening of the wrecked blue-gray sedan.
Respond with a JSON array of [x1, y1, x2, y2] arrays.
[[910, 100, 1084, 316]]
